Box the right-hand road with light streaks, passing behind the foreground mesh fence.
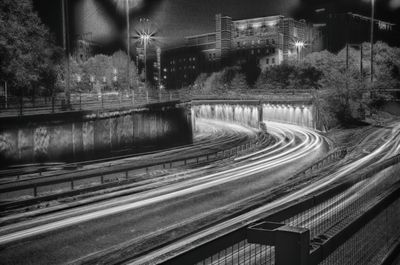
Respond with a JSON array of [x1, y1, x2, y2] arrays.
[[127, 123, 400, 265]]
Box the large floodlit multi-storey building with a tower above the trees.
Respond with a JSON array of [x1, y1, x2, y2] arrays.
[[161, 14, 322, 88]]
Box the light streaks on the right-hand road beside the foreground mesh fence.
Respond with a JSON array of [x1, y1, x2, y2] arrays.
[[129, 121, 400, 265]]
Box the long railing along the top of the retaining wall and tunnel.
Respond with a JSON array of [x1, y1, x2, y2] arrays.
[[0, 89, 312, 117]]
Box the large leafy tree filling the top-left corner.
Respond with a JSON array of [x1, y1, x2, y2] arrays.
[[0, 0, 62, 94]]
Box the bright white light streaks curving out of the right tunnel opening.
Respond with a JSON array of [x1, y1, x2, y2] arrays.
[[0, 120, 323, 244]]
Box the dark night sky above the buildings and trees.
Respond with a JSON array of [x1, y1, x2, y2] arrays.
[[34, 0, 400, 53]]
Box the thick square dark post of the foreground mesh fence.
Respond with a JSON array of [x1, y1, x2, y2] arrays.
[[275, 226, 310, 265]]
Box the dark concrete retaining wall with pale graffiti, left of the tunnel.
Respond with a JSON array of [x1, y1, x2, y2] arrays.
[[0, 105, 192, 166]]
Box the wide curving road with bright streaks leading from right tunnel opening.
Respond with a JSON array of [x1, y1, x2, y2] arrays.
[[0, 120, 327, 264]]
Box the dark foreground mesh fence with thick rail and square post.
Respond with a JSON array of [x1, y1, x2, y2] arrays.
[[157, 156, 400, 265]]
